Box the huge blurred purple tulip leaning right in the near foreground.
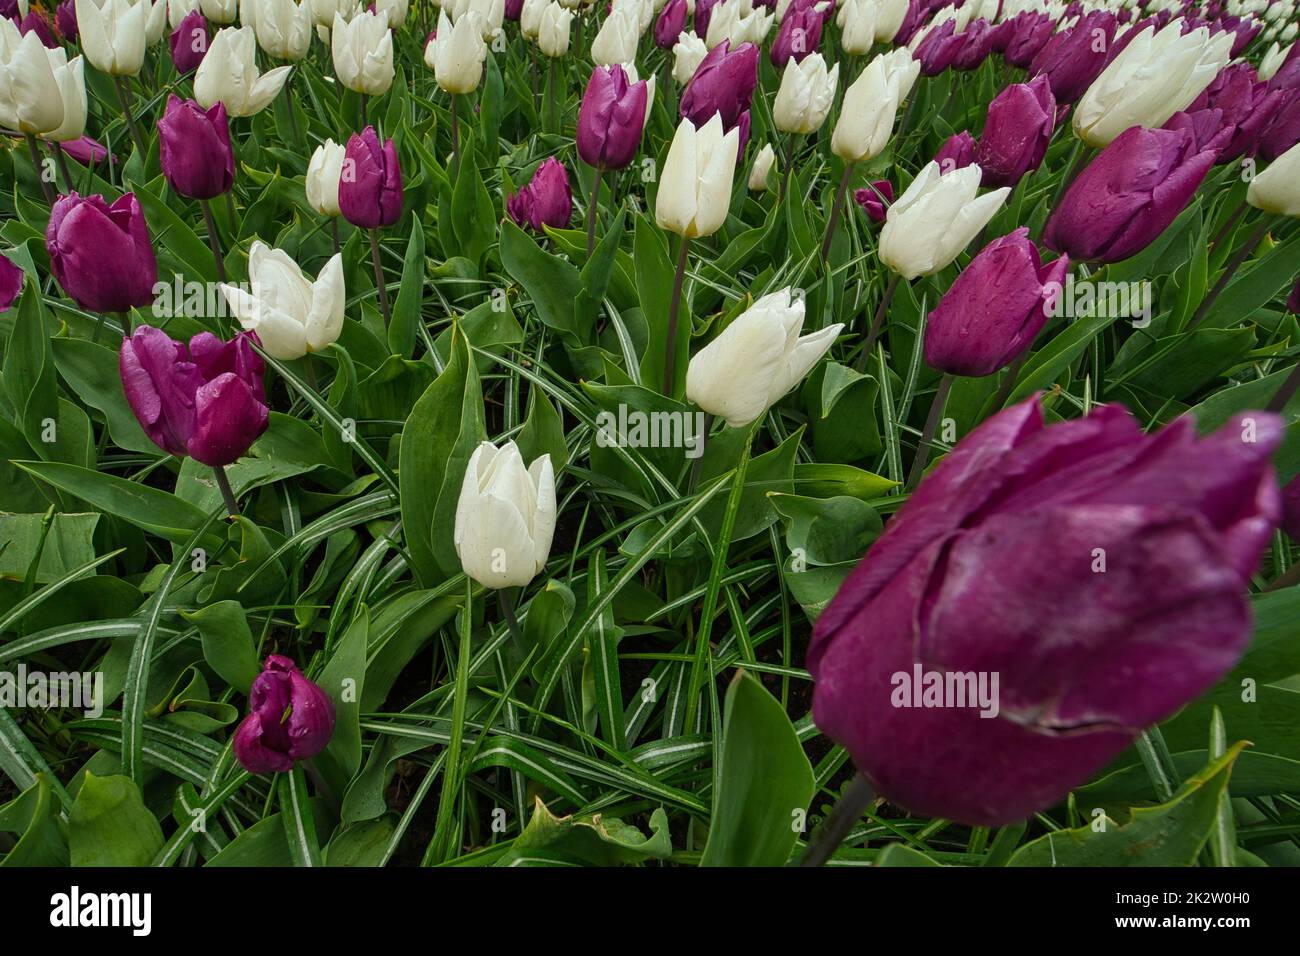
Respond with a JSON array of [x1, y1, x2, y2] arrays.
[[807, 397, 1282, 826]]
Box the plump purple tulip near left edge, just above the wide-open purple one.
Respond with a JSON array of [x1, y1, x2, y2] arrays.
[[46, 193, 157, 312]]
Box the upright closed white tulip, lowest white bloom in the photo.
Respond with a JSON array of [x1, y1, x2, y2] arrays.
[[454, 441, 556, 589]]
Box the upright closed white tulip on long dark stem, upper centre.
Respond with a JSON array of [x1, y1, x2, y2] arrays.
[[654, 113, 740, 239]]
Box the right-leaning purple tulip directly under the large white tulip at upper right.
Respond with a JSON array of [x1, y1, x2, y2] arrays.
[[1043, 126, 1218, 263]]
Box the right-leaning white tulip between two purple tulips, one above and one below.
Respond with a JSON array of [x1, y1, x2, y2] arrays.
[[880, 160, 1011, 280]]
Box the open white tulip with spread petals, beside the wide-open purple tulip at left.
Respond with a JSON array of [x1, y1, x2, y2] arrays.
[[221, 239, 346, 360]]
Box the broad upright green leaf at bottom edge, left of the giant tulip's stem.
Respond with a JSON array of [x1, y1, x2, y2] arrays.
[[699, 670, 816, 866]]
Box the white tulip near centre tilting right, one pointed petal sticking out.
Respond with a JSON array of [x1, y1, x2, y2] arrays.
[[686, 286, 844, 428]]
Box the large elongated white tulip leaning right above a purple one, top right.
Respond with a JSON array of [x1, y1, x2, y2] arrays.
[[1073, 20, 1235, 147]]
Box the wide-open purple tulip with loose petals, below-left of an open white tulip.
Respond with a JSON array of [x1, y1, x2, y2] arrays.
[[117, 325, 269, 468]]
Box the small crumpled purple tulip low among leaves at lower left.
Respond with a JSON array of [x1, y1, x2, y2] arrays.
[[230, 654, 334, 774]]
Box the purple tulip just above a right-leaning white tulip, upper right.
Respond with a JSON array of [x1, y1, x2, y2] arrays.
[[975, 74, 1057, 186]]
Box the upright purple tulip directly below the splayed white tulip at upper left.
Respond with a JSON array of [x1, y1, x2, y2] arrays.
[[159, 95, 235, 199]]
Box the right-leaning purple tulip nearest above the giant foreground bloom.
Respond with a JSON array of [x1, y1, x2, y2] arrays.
[[926, 226, 1070, 377]]
